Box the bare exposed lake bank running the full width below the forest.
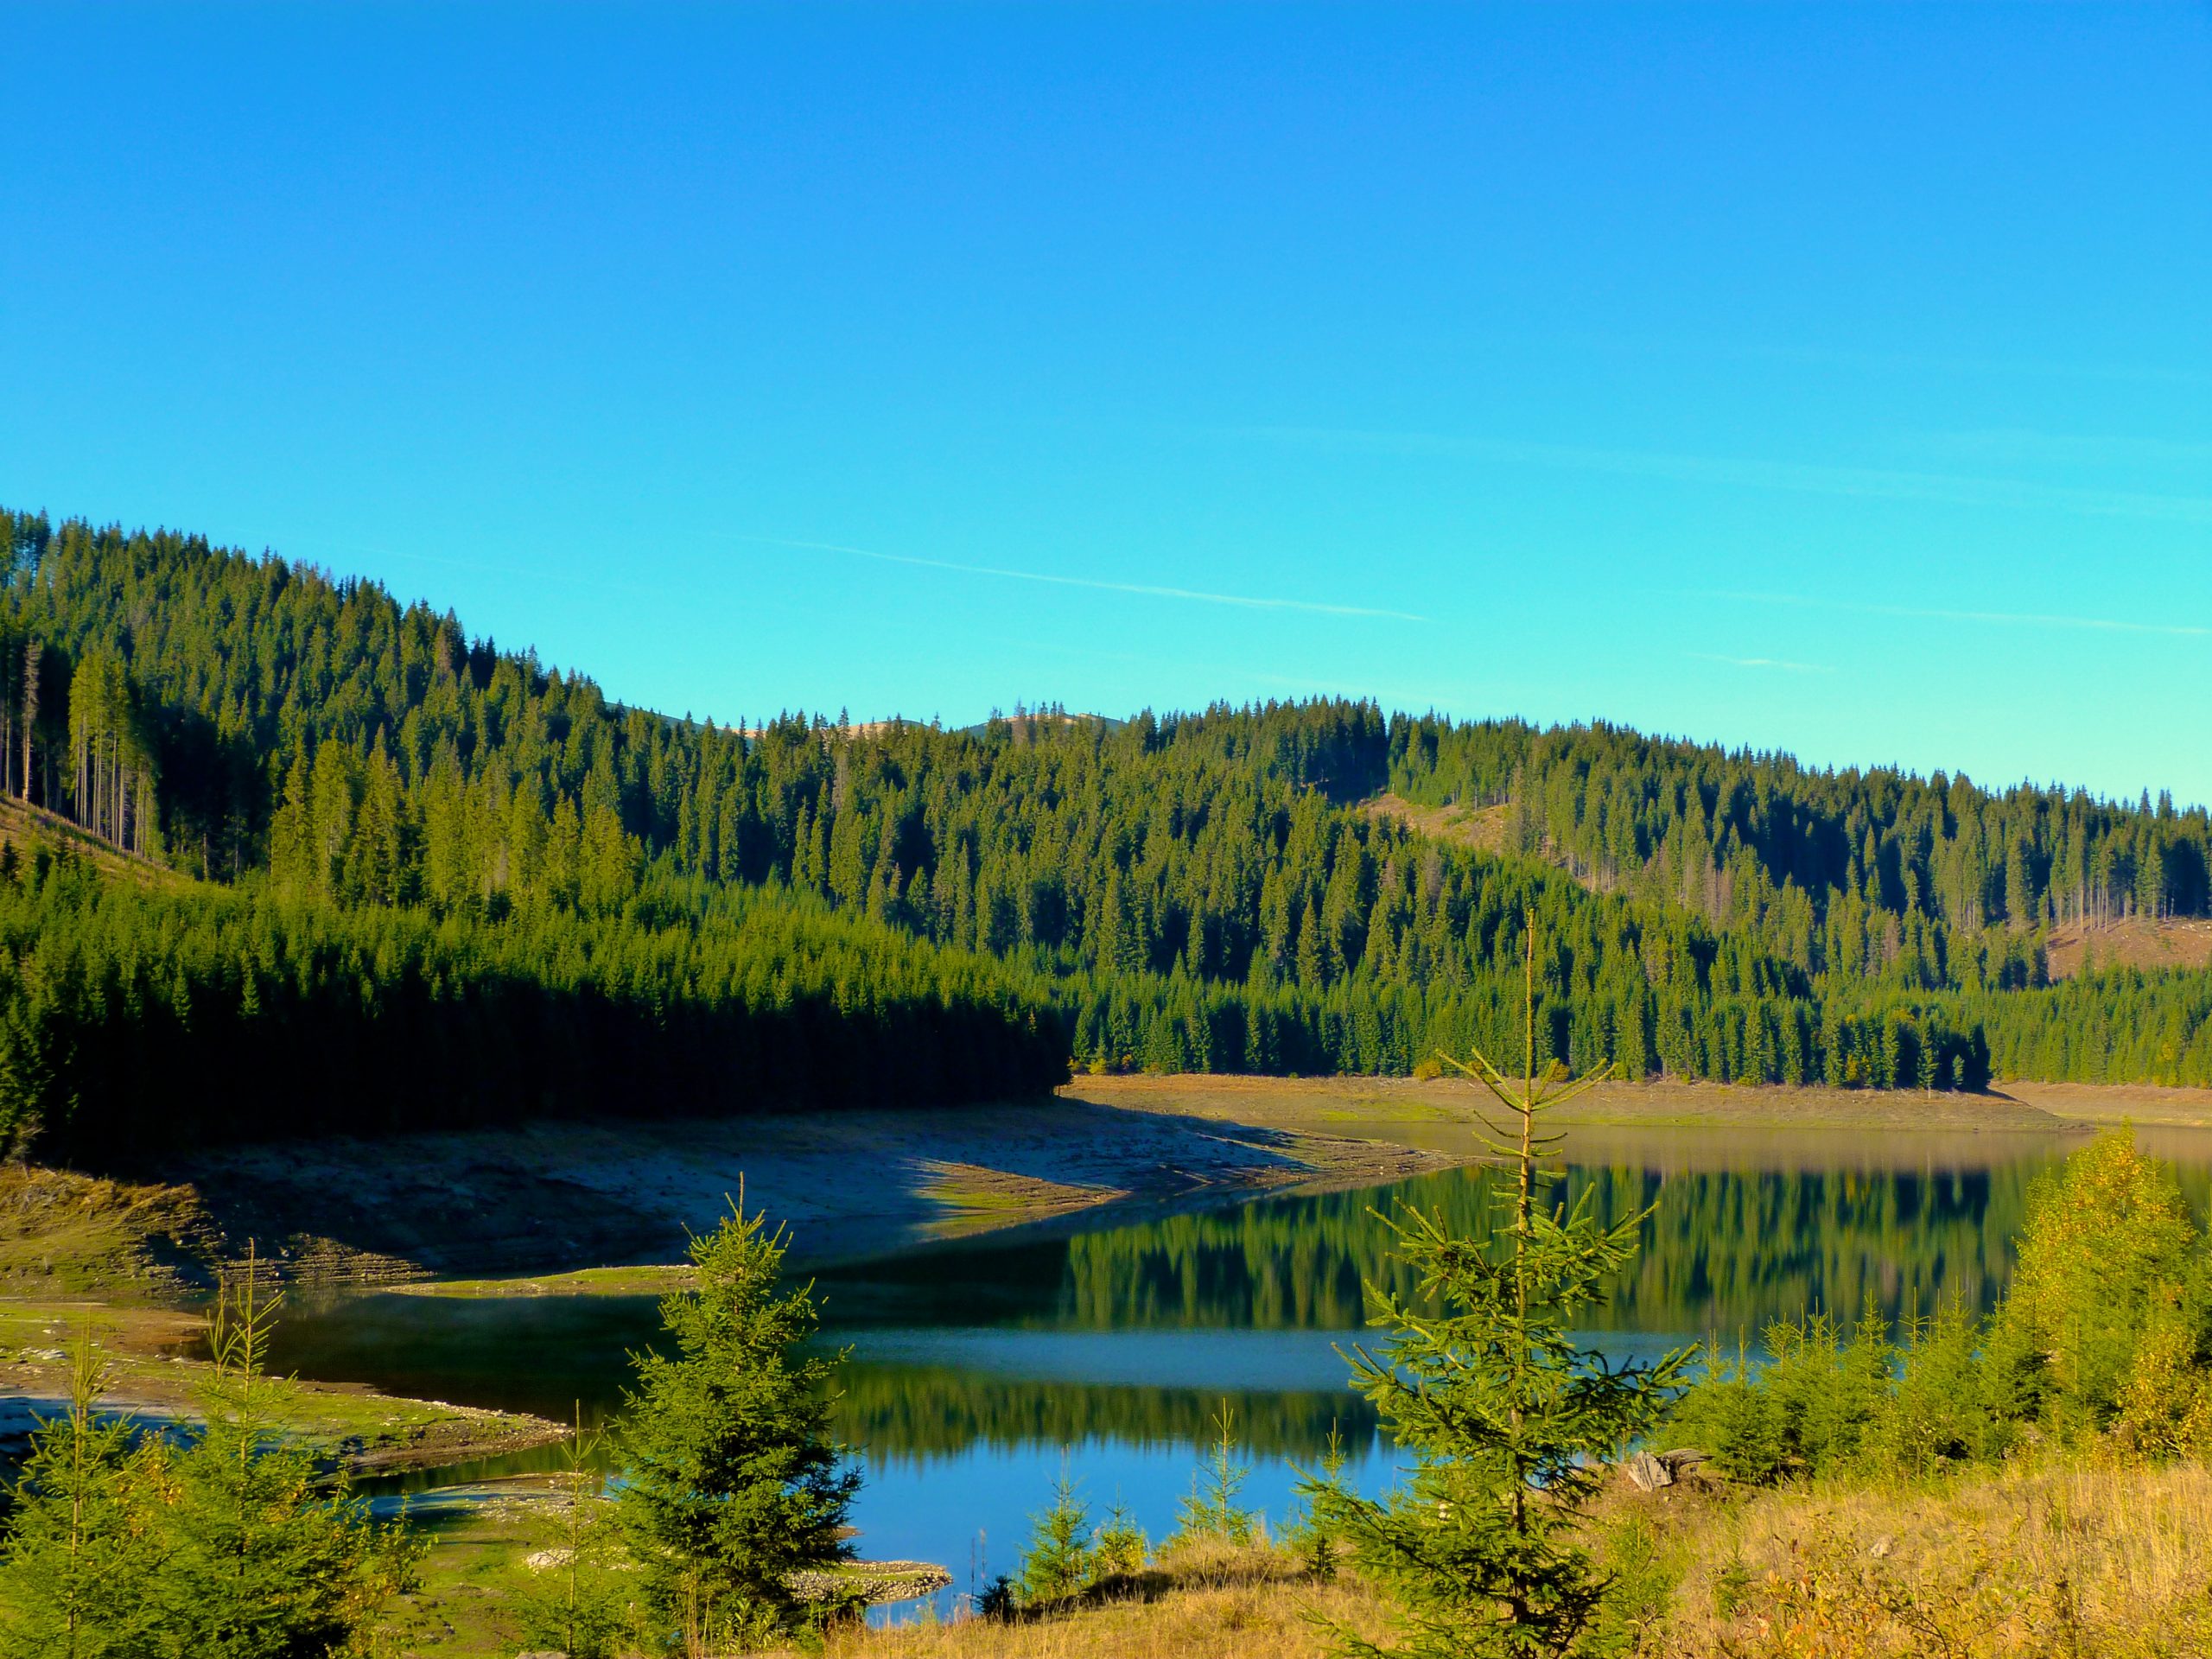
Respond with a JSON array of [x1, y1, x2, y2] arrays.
[[17, 1075, 2212, 1300]]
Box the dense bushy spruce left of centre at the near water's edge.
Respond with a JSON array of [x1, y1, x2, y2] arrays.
[[617, 1204, 861, 1642]]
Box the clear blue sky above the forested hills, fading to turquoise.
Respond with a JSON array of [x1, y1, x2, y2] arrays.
[[0, 4, 2212, 801]]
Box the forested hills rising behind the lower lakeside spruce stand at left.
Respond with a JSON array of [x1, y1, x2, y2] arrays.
[[0, 499, 2212, 1159]]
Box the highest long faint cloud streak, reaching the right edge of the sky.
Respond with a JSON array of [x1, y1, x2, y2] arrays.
[[1219, 427, 2212, 524]]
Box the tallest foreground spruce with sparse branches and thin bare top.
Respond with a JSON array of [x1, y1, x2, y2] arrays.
[[1314, 916, 1690, 1659]]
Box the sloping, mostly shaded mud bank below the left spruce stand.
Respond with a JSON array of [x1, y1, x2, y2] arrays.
[[60, 1089, 1440, 1289]]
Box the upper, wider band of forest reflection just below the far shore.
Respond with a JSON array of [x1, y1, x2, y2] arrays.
[[832, 1146, 2208, 1338]]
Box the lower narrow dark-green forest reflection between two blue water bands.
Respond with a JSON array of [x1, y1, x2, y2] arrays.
[[836, 1360, 1376, 1458]]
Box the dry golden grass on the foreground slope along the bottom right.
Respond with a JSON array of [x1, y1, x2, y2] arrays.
[[783, 1466, 2212, 1659]]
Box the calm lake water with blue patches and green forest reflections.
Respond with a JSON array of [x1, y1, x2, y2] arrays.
[[258, 1123, 2212, 1618]]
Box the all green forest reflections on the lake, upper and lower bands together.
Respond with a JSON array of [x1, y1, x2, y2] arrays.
[[825, 1144, 2212, 1460]]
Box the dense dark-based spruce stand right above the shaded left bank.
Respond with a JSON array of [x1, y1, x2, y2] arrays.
[[0, 854, 1066, 1166]]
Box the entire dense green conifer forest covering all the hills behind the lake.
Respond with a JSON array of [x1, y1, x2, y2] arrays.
[[0, 513, 2212, 1150]]
